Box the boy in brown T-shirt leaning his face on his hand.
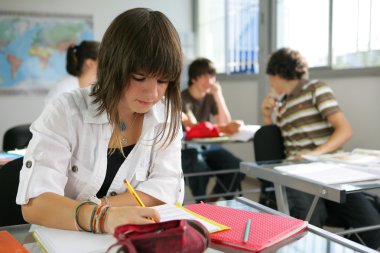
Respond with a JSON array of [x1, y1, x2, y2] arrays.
[[181, 58, 244, 201]]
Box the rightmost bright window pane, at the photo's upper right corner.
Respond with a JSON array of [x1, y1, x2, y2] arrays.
[[332, 0, 380, 69]]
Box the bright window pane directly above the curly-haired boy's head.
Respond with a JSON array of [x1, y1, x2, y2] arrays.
[[276, 0, 329, 67]]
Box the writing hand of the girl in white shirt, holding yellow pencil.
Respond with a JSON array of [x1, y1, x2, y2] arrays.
[[104, 206, 160, 234]]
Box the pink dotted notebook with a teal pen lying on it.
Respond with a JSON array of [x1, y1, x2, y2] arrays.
[[186, 203, 307, 252]]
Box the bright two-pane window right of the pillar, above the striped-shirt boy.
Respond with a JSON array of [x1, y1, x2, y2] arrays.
[[276, 0, 380, 69]]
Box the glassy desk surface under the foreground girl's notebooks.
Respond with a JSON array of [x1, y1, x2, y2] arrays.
[[0, 197, 377, 253]]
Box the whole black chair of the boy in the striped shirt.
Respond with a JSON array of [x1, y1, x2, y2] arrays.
[[253, 125, 286, 209]]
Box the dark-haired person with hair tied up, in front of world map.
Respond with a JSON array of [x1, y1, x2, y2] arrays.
[[45, 40, 100, 104]]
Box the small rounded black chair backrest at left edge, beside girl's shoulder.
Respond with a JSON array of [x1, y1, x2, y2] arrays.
[[3, 124, 32, 151]]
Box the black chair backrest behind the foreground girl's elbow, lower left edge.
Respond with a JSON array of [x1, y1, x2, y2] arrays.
[[0, 157, 27, 227]]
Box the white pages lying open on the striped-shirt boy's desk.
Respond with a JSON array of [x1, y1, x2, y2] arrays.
[[274, 162, 380, 184]]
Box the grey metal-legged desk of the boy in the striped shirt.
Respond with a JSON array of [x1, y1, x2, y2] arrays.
[[240, 160, 380, 220]]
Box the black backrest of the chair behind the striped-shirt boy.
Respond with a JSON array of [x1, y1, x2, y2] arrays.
[[253, 125, 285, 162]]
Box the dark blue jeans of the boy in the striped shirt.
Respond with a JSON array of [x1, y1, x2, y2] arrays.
[[286, 188, 380, 249]]
